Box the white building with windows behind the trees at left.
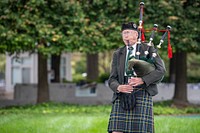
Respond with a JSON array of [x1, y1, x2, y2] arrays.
[[5, 53, 72, 92]]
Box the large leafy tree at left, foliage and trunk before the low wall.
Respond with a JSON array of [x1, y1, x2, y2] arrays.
[[0, 0, 84, 103]]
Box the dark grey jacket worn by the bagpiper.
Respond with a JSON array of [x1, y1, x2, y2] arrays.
[[108, 43, 166, 102]]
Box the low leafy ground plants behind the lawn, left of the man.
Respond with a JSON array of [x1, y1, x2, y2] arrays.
[[0, 102, 110, 114]]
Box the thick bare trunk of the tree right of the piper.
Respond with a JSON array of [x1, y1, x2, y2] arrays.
[[173, 51, 188, 105]]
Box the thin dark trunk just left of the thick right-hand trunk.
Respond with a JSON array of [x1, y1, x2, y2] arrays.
[[169, 53, 176, 83]]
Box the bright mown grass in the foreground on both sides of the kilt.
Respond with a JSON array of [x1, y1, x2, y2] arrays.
[[0, 113, 200, 133]]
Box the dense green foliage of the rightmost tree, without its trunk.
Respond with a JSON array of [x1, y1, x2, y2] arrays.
[[144, 0, 200, 53]]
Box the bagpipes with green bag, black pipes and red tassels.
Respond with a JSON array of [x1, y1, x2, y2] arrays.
[[127, 2, 172, 77]]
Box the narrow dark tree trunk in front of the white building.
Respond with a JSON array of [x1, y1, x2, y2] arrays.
[[51, 55, 60, 83]]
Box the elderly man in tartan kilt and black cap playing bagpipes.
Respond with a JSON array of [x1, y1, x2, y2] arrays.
[[108, 2, 166, 133]]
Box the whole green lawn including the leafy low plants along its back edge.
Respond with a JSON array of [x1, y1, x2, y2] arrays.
[[0, 101, 200, 133]]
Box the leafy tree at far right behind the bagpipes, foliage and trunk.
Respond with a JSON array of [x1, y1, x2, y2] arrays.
[[145, 0, 200, 104]]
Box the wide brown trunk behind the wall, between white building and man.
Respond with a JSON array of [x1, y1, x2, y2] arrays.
[[87, 54, 99, 81]]
